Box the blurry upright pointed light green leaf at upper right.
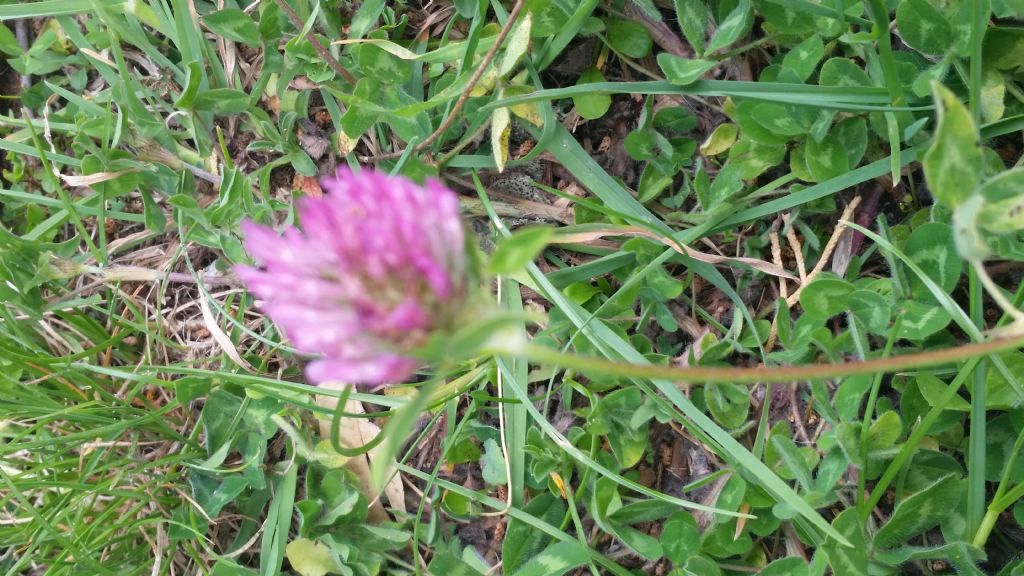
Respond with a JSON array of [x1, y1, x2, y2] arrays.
[[922, 82, 982, 208]]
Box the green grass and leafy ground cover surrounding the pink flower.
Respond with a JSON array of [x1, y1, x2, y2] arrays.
[[6, 0, 1024, 576]]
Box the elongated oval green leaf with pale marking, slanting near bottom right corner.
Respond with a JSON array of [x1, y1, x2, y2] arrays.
[[874, 476, 963, 548]]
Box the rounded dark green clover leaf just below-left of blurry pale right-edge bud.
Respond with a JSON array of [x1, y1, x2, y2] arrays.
[[903, 222, 964, 300]]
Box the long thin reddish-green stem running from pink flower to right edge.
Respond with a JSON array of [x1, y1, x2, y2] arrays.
[[499, 334, 1024, 384]]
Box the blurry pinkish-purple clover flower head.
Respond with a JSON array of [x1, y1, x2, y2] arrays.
[[236, 169, 467, 385]]
